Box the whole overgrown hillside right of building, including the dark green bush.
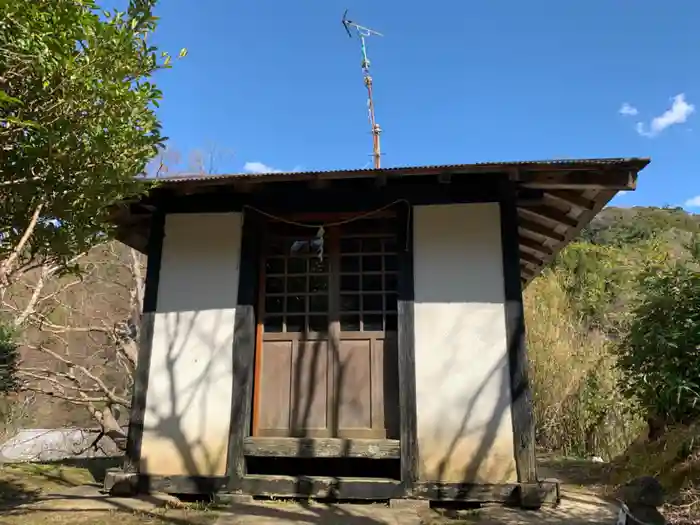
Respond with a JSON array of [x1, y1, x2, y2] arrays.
[[525, 203, 700, 523]]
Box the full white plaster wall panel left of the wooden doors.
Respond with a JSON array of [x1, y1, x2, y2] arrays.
[[141, 213, 242, 476]]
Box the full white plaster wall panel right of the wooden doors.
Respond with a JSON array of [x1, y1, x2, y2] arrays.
[[414, 203, 517, 483]]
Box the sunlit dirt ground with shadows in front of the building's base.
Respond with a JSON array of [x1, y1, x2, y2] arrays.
[[0, 459, 616, 525]]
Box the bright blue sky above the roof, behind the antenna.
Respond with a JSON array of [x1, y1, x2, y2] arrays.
[[142, 0, 700, 209]]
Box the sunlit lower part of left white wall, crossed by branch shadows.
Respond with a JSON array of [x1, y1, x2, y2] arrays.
[[140, 309, 235, 493]]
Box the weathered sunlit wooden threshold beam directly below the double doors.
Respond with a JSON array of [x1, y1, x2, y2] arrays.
[[243, 437, 401, 459]]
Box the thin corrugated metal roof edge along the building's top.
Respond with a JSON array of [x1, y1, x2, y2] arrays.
[[158, 157, 650, 183]]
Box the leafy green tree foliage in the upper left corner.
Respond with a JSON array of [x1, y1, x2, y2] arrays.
[[0, 0, 184, 291]]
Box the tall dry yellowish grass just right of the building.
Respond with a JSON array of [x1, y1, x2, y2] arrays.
[[525, 272, 644, 459]]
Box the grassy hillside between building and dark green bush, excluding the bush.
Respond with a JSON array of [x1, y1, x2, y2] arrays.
[[525, 207, 700, 448]]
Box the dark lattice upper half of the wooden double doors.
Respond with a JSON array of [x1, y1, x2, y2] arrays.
[[264, 219, 398, 333]]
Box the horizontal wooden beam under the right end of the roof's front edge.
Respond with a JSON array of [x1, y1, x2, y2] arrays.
[[520, 170, 637, 190]]
